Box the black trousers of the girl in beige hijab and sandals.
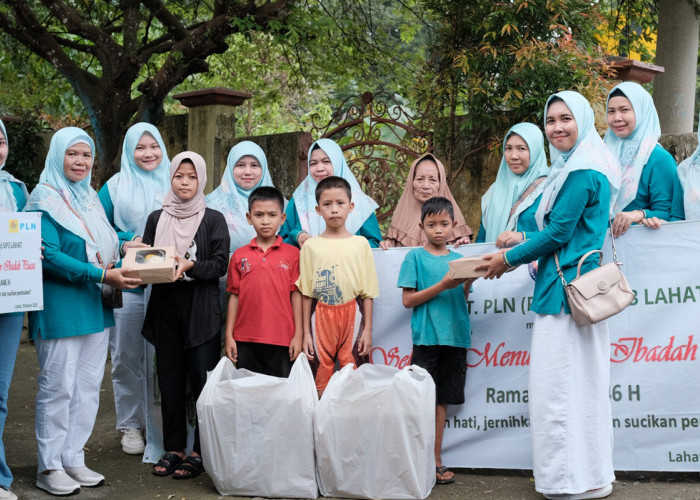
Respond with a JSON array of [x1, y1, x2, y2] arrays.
[[156, 326, 221, 453]]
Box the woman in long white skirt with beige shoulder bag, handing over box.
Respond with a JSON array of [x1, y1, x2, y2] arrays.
[[482, 91, 620, 499]]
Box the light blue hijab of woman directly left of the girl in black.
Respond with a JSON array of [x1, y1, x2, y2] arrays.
[[107, 122, 170, 234]]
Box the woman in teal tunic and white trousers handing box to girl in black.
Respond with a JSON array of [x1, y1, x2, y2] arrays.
[[24, 127, 141, 495]]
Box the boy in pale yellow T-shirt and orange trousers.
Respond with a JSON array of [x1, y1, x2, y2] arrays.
[[297, 176, 379, 396]]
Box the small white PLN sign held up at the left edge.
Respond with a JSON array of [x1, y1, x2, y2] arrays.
[[0, 212, 44, 313]]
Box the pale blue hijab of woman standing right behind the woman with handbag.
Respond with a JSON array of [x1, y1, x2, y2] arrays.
[[605, 82, 661, 215]]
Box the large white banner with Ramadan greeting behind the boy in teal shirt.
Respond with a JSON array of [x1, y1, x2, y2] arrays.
[[372, 221, 700, 471]]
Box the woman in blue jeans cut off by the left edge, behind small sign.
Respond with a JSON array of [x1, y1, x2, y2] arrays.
[[0, 120, 28, 499]]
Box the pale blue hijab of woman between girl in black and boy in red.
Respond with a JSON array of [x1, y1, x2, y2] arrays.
[[206, 141, 273, 253]]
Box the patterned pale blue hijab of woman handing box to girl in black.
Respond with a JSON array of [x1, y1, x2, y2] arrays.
[[24, 127, 119, 266]]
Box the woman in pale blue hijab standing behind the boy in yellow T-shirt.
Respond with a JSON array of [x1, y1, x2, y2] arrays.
[[280, 139, 382, 248]]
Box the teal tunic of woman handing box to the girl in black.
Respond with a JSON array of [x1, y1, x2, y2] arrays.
[[29, 212, 114, 339]]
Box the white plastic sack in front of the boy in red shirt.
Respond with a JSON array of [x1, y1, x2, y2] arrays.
[[197, 353, 318, 498]]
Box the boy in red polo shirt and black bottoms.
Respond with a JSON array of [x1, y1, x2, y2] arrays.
[[226, 186, 303, 377]]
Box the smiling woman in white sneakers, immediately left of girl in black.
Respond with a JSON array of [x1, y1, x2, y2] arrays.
[[99, 123, 170, 455]]
